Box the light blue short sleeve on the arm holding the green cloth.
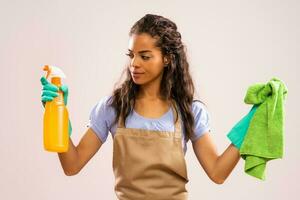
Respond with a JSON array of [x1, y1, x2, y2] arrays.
[[191, 101, 211, 142]]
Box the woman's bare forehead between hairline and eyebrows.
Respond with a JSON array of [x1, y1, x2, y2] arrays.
[[128, 33, 159, 52]]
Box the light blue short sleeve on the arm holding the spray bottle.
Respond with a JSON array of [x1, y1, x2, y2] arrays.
[[87, 96, 114, 143]]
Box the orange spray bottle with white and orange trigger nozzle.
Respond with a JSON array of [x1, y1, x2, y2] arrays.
[[43, 65, 69, 152]]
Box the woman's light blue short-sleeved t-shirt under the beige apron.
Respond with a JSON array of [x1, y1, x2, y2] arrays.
[[88, 96, 210, 154]]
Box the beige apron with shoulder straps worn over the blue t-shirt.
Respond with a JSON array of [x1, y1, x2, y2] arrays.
[[113, 102, 189, 200]]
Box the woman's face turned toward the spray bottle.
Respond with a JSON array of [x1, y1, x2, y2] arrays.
[[126, 33, 167, 85]]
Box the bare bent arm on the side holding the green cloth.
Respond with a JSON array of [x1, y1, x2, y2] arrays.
[[193, 133, 240, 184]]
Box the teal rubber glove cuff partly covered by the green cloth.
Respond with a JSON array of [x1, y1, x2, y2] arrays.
[[227, 105, 258, 149]]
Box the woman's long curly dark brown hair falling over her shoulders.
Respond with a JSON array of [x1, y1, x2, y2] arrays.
[[110, 14, 201, 138]]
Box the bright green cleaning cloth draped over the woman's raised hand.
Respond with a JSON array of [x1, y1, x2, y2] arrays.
[[240, 78, 287, 180]]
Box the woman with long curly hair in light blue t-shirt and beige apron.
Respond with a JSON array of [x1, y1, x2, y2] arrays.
[[42, 14, 240, 200]]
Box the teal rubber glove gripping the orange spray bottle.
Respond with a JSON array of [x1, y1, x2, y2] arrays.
[[40, 77, 72, 136]]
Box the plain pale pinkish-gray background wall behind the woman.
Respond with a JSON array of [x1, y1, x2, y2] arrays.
[[0, 0, 300, 200]]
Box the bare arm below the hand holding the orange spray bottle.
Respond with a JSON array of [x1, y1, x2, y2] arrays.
[[58, 128, 102, 176]]
